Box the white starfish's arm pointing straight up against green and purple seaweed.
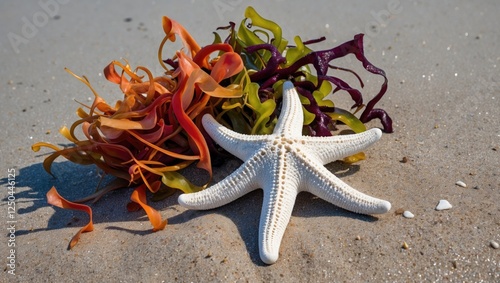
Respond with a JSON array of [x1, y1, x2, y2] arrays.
[[273, 81, 304, 137]]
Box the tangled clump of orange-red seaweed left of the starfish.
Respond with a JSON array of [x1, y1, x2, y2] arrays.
[[32, 11, 244, 246]]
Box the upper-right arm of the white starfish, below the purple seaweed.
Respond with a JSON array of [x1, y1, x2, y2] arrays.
[[301, 128, 382, 164]]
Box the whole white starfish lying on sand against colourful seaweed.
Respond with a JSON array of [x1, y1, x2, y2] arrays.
[[179, 82, 391, 264]]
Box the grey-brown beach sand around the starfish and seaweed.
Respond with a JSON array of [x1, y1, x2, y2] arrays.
[[0, 0, 500, 282]]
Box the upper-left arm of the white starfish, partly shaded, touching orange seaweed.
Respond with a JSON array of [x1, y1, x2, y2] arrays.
[[202, 114, 269, 160]]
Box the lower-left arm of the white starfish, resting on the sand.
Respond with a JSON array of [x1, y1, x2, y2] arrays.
[[178, 158, 262, 210]]
